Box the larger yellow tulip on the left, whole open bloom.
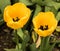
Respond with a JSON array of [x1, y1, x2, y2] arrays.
[[4, 3, 31, 29]]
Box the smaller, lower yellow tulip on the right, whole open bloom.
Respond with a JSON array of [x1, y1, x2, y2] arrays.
[[32, 12, 57, 37]]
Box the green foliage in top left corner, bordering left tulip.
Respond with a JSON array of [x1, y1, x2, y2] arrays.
[[0, 0, 11, 25]]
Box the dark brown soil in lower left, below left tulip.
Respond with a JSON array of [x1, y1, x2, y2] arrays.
[[0, 24, 15, 51]]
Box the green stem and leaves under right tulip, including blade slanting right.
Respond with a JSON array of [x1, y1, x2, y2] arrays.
[[39, 36, 56, 51]]
